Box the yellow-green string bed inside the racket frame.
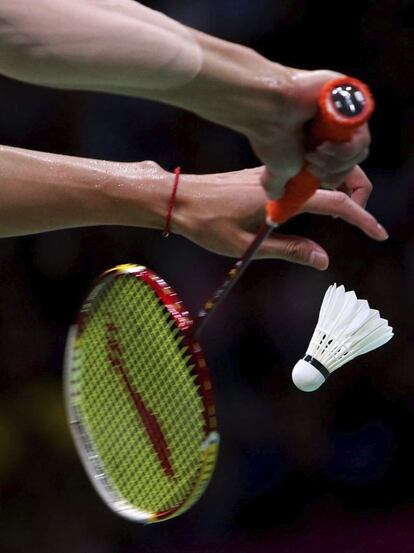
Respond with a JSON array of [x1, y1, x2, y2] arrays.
[[73, 276, 205, 512]]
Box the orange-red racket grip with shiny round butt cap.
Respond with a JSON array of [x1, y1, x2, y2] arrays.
[[266, 77, 375, 226]]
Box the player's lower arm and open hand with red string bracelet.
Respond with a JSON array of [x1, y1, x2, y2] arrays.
[[0, 146, 386, 270]]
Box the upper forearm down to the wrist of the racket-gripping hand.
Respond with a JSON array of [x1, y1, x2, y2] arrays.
[[0, 0, 290, 134]]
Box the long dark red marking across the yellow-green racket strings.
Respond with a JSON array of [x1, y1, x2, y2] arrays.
[[106, 319, 175, 478]]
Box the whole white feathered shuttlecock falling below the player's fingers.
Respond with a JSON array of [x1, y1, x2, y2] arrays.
[[292, 284, 394, 392]]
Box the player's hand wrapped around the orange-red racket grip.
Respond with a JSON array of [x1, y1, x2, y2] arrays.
[[250, 69, 370, 199]]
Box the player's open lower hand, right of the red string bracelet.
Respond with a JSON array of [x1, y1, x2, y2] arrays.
[[173, 167, 388, 270]]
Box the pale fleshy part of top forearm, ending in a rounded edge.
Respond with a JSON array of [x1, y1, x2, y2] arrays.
[[0, 0, 201, 90]]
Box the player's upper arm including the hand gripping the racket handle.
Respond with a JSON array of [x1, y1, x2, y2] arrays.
[[0, 0, 369, 197]]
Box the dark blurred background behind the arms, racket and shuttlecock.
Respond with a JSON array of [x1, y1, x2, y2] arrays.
[[0, 0, 414, 553]]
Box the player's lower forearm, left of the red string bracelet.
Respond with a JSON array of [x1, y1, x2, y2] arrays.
[[0, 146, 173, 237]]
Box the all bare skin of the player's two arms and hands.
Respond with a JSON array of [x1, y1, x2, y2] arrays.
[[0, 0, 387, 270]]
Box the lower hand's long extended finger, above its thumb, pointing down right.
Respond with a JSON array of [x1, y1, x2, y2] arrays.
[[305, 190, 388, 241]]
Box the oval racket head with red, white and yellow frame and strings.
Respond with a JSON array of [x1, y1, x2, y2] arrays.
[[64, 265, 219, 523]]
